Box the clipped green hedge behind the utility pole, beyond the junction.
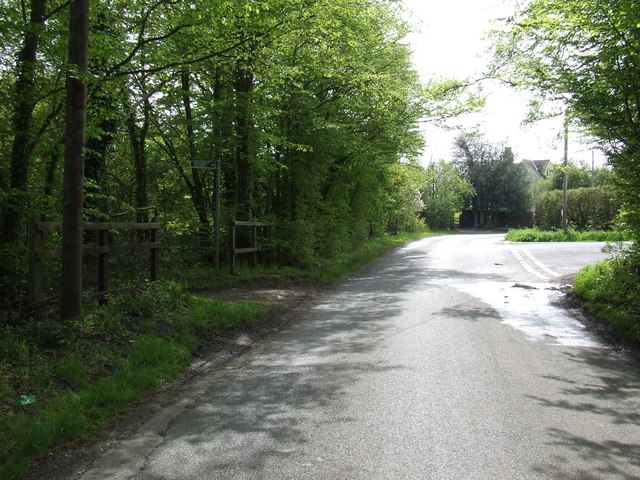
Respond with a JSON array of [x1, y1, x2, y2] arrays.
[[533, 187, 620, 230]]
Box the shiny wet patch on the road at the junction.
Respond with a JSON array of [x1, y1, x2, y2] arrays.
[[452, 282, 604, 348]]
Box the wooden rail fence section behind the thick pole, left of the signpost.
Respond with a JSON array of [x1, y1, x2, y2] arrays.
[[28, 207, 160, 305]]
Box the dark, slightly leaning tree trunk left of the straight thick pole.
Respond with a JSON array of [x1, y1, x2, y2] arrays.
[[0, 0, 47, 243]]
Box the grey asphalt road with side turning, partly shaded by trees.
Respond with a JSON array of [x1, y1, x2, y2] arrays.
[[82, 235, 640, 480]]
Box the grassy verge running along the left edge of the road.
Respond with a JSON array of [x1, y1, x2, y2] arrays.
[[0, 232, 445, 480]]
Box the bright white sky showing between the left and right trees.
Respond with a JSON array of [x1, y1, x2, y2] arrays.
[[403, 0, 603, 165]]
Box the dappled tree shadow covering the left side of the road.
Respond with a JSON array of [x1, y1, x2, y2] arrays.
[[139, 244, 449, 480]]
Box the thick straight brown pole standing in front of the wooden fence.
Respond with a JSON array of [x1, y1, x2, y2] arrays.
[[60, 0, 89, 320]]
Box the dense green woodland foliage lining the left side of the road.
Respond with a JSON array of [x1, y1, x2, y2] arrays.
[[0, 0, 478, 306]]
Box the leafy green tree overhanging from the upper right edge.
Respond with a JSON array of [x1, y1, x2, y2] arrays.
[[496, 0, 640, 238]]
